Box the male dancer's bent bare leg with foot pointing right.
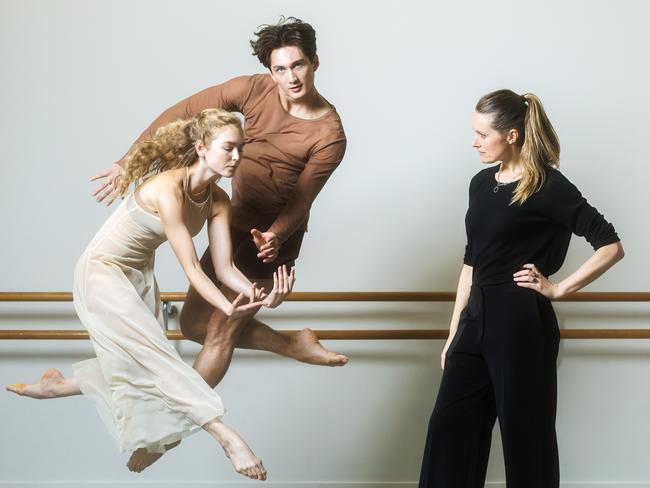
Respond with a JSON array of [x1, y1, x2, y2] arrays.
[[180, 280, 348, 370]]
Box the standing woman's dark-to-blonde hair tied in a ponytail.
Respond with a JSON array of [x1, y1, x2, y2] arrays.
[[476, 90, 560, 204]]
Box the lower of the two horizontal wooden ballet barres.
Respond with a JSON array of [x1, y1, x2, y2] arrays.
[[0, 329, 650, 341]]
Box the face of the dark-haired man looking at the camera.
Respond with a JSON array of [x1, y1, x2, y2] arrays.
[[270, 46, 318, 102]]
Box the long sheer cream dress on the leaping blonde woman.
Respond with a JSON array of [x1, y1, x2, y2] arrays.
[[73, 172, 224, 452]]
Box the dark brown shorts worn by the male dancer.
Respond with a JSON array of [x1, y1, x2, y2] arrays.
[[201, 226, 305, 283]]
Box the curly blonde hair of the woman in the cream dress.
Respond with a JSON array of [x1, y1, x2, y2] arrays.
[[115, 108, 243, 196]]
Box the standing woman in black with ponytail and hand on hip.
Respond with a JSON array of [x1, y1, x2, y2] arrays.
[[420, 90, 623, 488]]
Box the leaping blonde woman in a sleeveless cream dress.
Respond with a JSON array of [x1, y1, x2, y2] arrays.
[[7, 109, 295, 480]]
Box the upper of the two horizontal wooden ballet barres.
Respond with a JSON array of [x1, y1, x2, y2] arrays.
[[0, 291, 650, 302]]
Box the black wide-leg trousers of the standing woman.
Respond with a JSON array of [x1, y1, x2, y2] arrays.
[[419, 284, 560, 488]]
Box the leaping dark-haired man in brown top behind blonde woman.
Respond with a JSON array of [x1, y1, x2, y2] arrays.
[[91, 17, 348, 387]]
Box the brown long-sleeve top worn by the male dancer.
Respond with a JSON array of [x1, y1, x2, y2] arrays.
[[123, 74, 346, 241]]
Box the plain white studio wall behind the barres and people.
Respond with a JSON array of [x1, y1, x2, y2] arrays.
[[0, 0, 650, 487]]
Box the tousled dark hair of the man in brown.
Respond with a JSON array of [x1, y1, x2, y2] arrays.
[[251, 16, 316, 69]]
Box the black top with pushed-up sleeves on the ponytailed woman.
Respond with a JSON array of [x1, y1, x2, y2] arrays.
[[464, 166, 619, 286]]
